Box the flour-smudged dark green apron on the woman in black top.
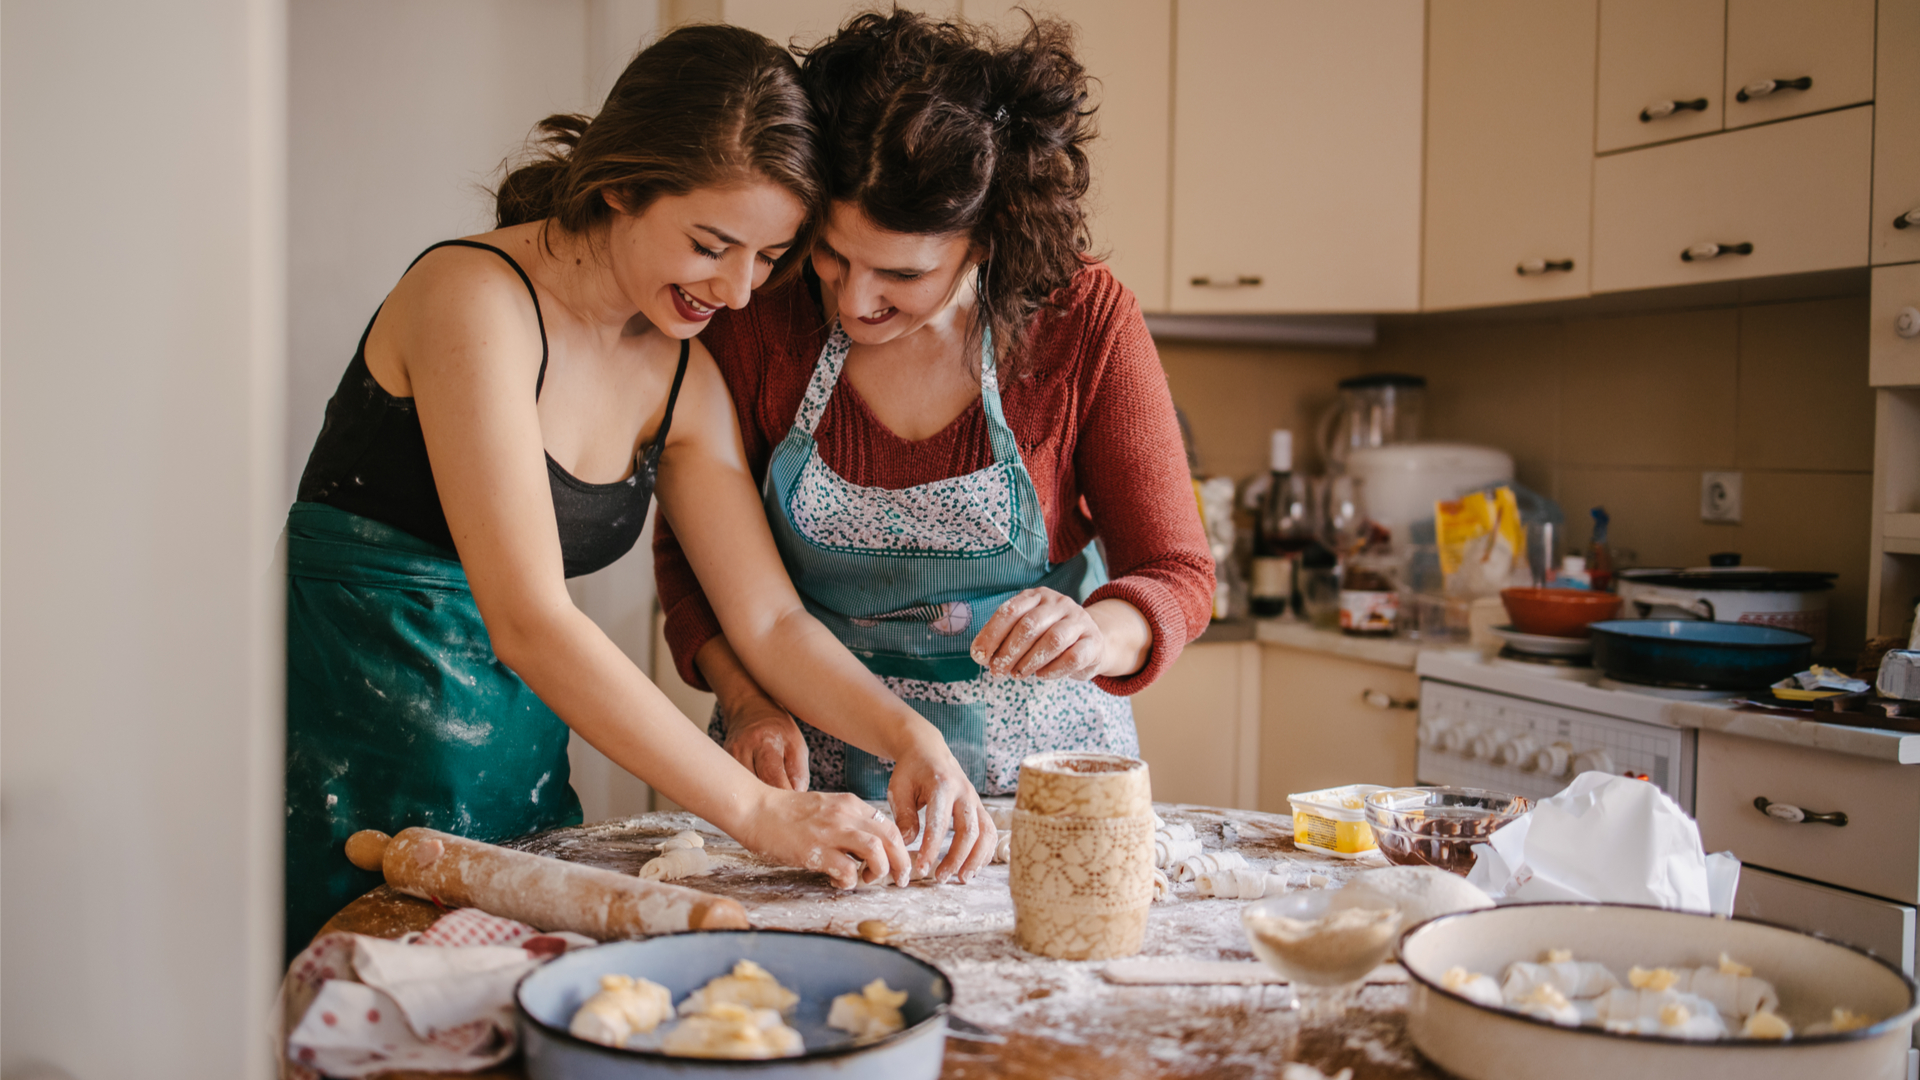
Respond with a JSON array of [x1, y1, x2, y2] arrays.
[[286, 502, 580, 957]]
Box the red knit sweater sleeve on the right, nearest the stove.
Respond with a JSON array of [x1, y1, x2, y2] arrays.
[[1073, 274, 1213, 694]]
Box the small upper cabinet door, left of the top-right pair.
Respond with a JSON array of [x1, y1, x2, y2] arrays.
[[1589, 0, 1728, 154]]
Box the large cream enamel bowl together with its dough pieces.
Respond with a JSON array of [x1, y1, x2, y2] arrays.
[[1400, 903, 1920, 1080]]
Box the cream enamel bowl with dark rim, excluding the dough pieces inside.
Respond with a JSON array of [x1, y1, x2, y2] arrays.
[[1400, 903, 1920, 1080]]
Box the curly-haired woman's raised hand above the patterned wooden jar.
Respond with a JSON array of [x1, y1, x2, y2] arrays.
[[972, 588, 1154, 678]]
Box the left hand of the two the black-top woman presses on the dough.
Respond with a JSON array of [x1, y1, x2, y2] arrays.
[[739, 788, 912, 888]]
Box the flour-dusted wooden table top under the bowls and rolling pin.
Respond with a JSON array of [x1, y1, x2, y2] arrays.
[[307, 807, 1440, 1080]]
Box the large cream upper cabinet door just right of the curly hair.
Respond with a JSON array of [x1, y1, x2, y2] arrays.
[[1171, 0, 1420, 313]]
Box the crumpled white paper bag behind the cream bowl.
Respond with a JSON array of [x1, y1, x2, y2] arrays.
[[1467, 773, 1740, 915]]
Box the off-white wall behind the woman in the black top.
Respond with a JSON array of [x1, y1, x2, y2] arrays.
[[284, 0, 660, 821]]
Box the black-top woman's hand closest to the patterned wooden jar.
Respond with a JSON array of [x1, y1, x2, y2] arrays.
[[887, 723, 998, 884]]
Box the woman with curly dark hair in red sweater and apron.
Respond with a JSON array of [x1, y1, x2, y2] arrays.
[[655, 12, 1213, 814]]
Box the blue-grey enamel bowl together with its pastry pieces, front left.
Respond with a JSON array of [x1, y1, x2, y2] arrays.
[[515, 930, 952, 1080]]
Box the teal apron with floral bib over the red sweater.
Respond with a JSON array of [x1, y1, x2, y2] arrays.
[[720, 321, 1139, 799]]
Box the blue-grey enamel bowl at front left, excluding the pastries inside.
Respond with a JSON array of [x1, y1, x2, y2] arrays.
[[515, 930, 952, 1080]]
